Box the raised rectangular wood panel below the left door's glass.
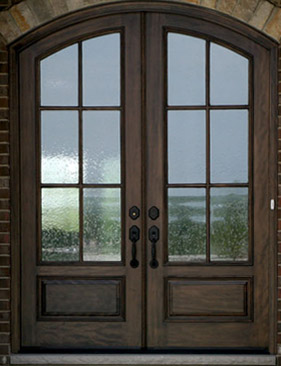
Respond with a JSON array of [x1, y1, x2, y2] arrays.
[[38, 277, 125, 319]]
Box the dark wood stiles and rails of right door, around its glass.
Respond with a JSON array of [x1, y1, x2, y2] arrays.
[[146, 14, 271, 349]]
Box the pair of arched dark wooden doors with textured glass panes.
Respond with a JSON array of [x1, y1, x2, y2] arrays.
[[20, 13, 270, 350]]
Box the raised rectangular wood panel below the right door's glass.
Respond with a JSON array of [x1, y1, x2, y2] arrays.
[[165, 278, 252, 321]]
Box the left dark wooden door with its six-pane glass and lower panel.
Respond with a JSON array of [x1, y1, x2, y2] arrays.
[[20, 15, 142, 350]]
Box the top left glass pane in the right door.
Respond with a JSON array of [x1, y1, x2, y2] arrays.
[[168, 33, 206, 105]]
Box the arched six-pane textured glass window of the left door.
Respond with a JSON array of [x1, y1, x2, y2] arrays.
[[39, 33, 123, 262]]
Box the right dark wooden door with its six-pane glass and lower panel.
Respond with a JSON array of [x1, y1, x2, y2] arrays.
[[146, 14, 270, 350]]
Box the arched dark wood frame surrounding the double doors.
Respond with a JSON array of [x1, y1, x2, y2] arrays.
[[9, 1, 278, 354]]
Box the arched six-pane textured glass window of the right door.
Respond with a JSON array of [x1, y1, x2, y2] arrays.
[[166, 32, 251, 263]]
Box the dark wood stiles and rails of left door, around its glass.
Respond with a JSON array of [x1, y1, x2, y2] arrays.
[[20, 14, 142, 349]]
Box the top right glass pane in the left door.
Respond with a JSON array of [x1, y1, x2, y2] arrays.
[[83, 33, 120, 106]]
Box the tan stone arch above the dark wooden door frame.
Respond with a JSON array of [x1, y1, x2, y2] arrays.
[[0, 0, 281, 44]]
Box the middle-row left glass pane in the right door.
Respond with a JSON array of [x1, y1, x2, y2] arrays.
[[168, 111, 206, 183]]
